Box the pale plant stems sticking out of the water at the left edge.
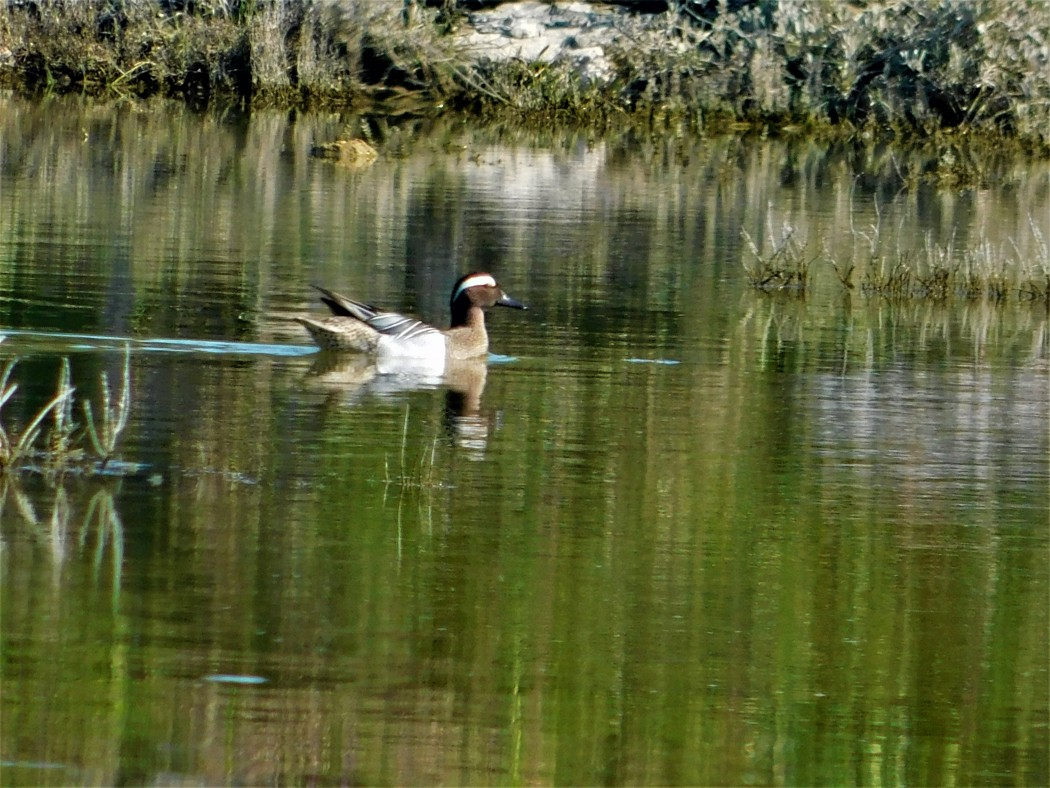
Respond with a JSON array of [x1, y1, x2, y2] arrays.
[[0, 348, 131, 475]]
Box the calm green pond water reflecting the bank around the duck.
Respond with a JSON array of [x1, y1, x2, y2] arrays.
[[0, 97, 1050, 785]]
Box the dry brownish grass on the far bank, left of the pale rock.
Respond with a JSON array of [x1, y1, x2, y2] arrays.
[[0, 0, 424, 104]]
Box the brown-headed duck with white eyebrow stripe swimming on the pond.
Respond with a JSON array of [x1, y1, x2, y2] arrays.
[[295, 271, 527, 374]]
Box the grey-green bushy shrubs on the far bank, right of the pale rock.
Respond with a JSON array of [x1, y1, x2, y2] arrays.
[[618, 0, 1050, 148]]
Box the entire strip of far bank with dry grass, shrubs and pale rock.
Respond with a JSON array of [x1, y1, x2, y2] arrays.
[[0, 0, 1050, 155]]
